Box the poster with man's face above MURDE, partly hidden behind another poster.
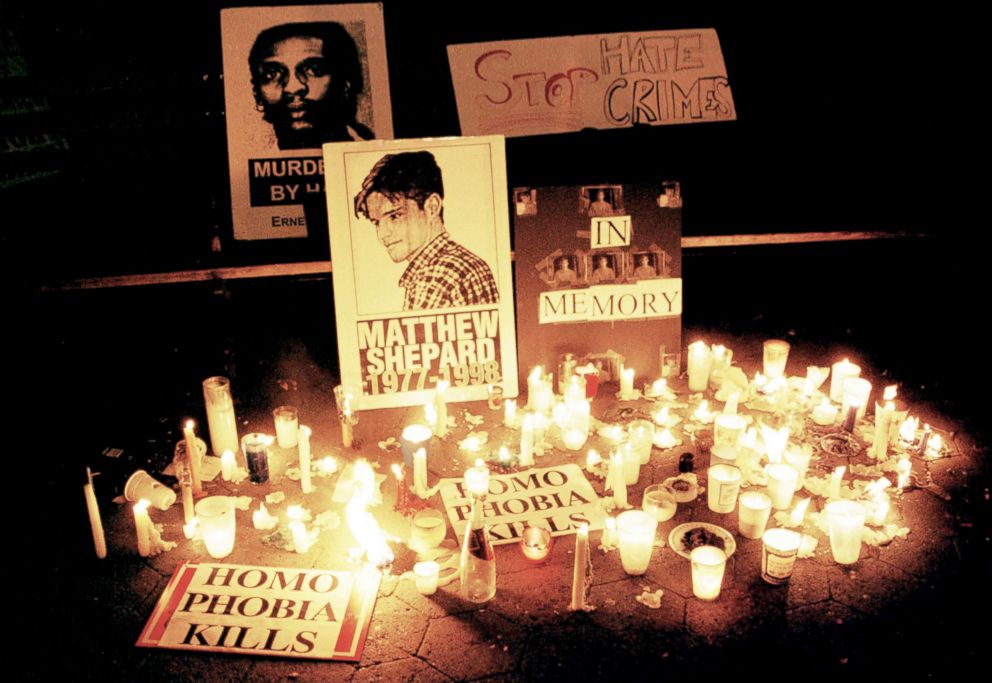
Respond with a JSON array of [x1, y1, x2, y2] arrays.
[[220, 4, 393, 240]]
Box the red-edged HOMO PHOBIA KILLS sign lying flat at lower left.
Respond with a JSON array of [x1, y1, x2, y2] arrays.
[[137, 562, 381, 662]]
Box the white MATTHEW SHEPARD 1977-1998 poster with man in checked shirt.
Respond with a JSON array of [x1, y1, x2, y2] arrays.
[[324, 136, 517, 409]]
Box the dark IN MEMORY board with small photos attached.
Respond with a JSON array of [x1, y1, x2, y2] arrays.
[[513, 181, 683, 384]]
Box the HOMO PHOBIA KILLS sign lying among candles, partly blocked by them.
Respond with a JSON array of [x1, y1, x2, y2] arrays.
[[440, 464, 606, 545]]
